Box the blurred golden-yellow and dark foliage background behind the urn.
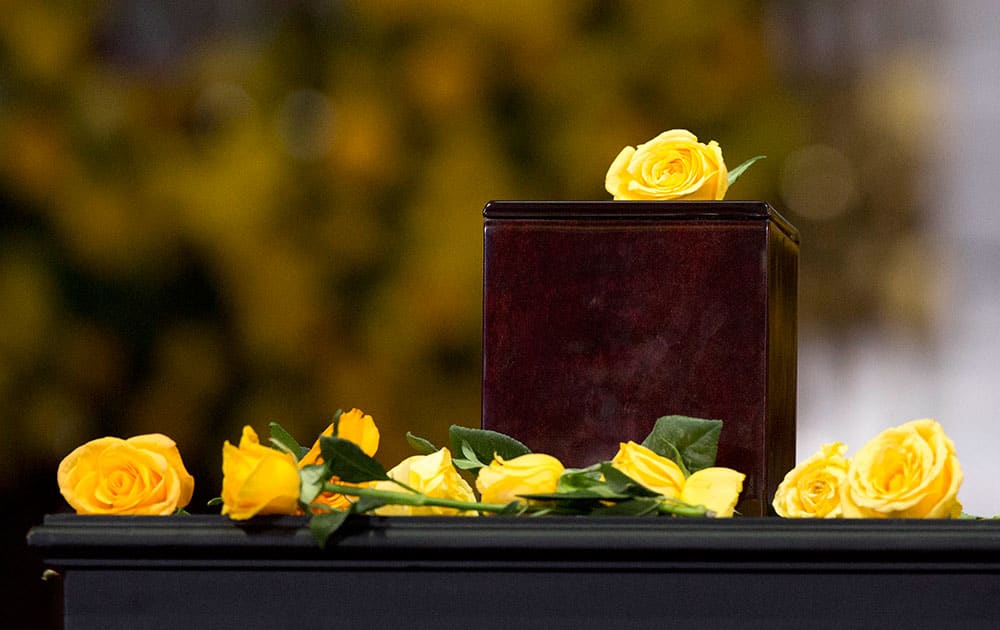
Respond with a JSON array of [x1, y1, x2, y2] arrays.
[[0, 0, 964, 627]]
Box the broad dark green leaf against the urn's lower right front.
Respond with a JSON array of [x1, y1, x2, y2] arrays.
[[642, 416, 722, 473]]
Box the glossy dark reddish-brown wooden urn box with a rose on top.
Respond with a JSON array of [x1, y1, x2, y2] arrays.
[[483, 201, 798, 515]]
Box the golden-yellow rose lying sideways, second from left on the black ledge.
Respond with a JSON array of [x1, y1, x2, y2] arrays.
[[222, 426, 299, 521]]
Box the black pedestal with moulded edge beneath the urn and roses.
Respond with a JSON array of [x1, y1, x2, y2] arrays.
[[29, 515, 1000, 630]]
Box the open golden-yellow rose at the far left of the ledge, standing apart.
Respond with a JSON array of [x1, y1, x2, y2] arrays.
[[56, 433, 194, 515]]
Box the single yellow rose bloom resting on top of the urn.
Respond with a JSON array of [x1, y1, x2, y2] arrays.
[[604, 129, 729, 201]]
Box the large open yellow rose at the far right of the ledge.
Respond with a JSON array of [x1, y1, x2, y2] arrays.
[[840, 419, 962, 518]]
